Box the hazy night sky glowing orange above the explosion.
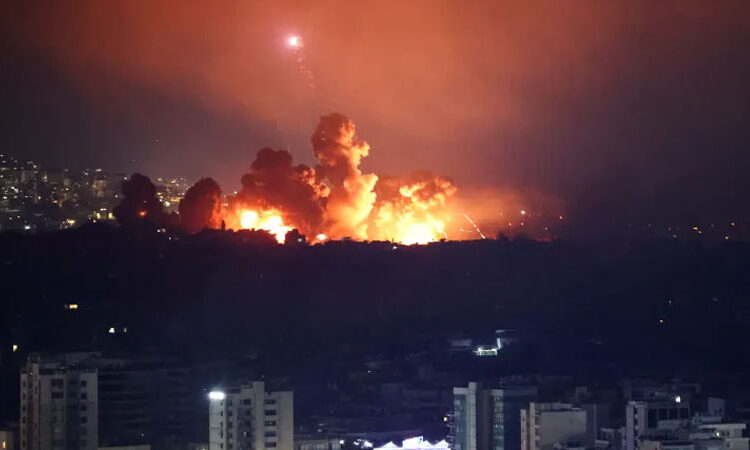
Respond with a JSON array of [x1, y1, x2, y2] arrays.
[[0, 0, 750, 225]]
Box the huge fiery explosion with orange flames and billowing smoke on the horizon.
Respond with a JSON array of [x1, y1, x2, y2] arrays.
[[172, 113, 564, 245]]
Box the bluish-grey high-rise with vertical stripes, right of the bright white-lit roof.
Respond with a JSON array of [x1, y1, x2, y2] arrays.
[[450, 382, 537, 450]]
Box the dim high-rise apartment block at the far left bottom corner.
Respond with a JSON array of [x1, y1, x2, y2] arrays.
[[19, 354, 98, 450]]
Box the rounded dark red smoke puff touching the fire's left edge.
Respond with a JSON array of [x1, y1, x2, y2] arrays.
[[179, 178, 222, 233]]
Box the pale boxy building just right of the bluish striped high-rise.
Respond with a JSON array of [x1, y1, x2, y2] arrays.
[[521, 402, 587, 450]]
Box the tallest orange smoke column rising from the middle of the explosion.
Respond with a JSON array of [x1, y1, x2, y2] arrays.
[[311, 113, 378, 239]]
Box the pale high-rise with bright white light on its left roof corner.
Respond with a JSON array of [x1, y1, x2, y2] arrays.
[[208, 381, 294, 450]]
